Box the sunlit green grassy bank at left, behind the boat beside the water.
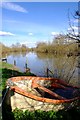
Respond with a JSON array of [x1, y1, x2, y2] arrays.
[[0, 62, 34, 89]]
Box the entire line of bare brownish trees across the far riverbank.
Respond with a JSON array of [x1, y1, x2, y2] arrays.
[[0, 34, 78, 55]]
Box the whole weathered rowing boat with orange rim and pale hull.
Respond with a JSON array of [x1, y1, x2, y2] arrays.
[[7, 76, 80, 111]]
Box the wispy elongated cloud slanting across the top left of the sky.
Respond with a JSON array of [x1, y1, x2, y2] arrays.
[[0, 2, 28, 13]]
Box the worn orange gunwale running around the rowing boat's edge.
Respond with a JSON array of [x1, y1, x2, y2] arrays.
[[7, 76, 80, 104]]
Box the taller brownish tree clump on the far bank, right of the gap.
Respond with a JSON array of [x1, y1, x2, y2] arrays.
[[35, 34, 78, 55]]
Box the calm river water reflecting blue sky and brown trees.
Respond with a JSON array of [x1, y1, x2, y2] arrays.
[[7, 52, 80, 86]]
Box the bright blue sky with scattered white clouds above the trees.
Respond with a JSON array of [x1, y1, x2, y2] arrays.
[[0, 0, 78, 47]]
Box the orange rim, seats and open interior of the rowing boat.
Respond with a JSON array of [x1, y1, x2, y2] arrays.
[[7, 76, 80, 104]]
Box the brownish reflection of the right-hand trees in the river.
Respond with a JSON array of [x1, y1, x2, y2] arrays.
[[37, 54, 78, 82]]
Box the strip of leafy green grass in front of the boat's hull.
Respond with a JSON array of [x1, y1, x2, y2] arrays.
[[4, 108, 80, 120]]
